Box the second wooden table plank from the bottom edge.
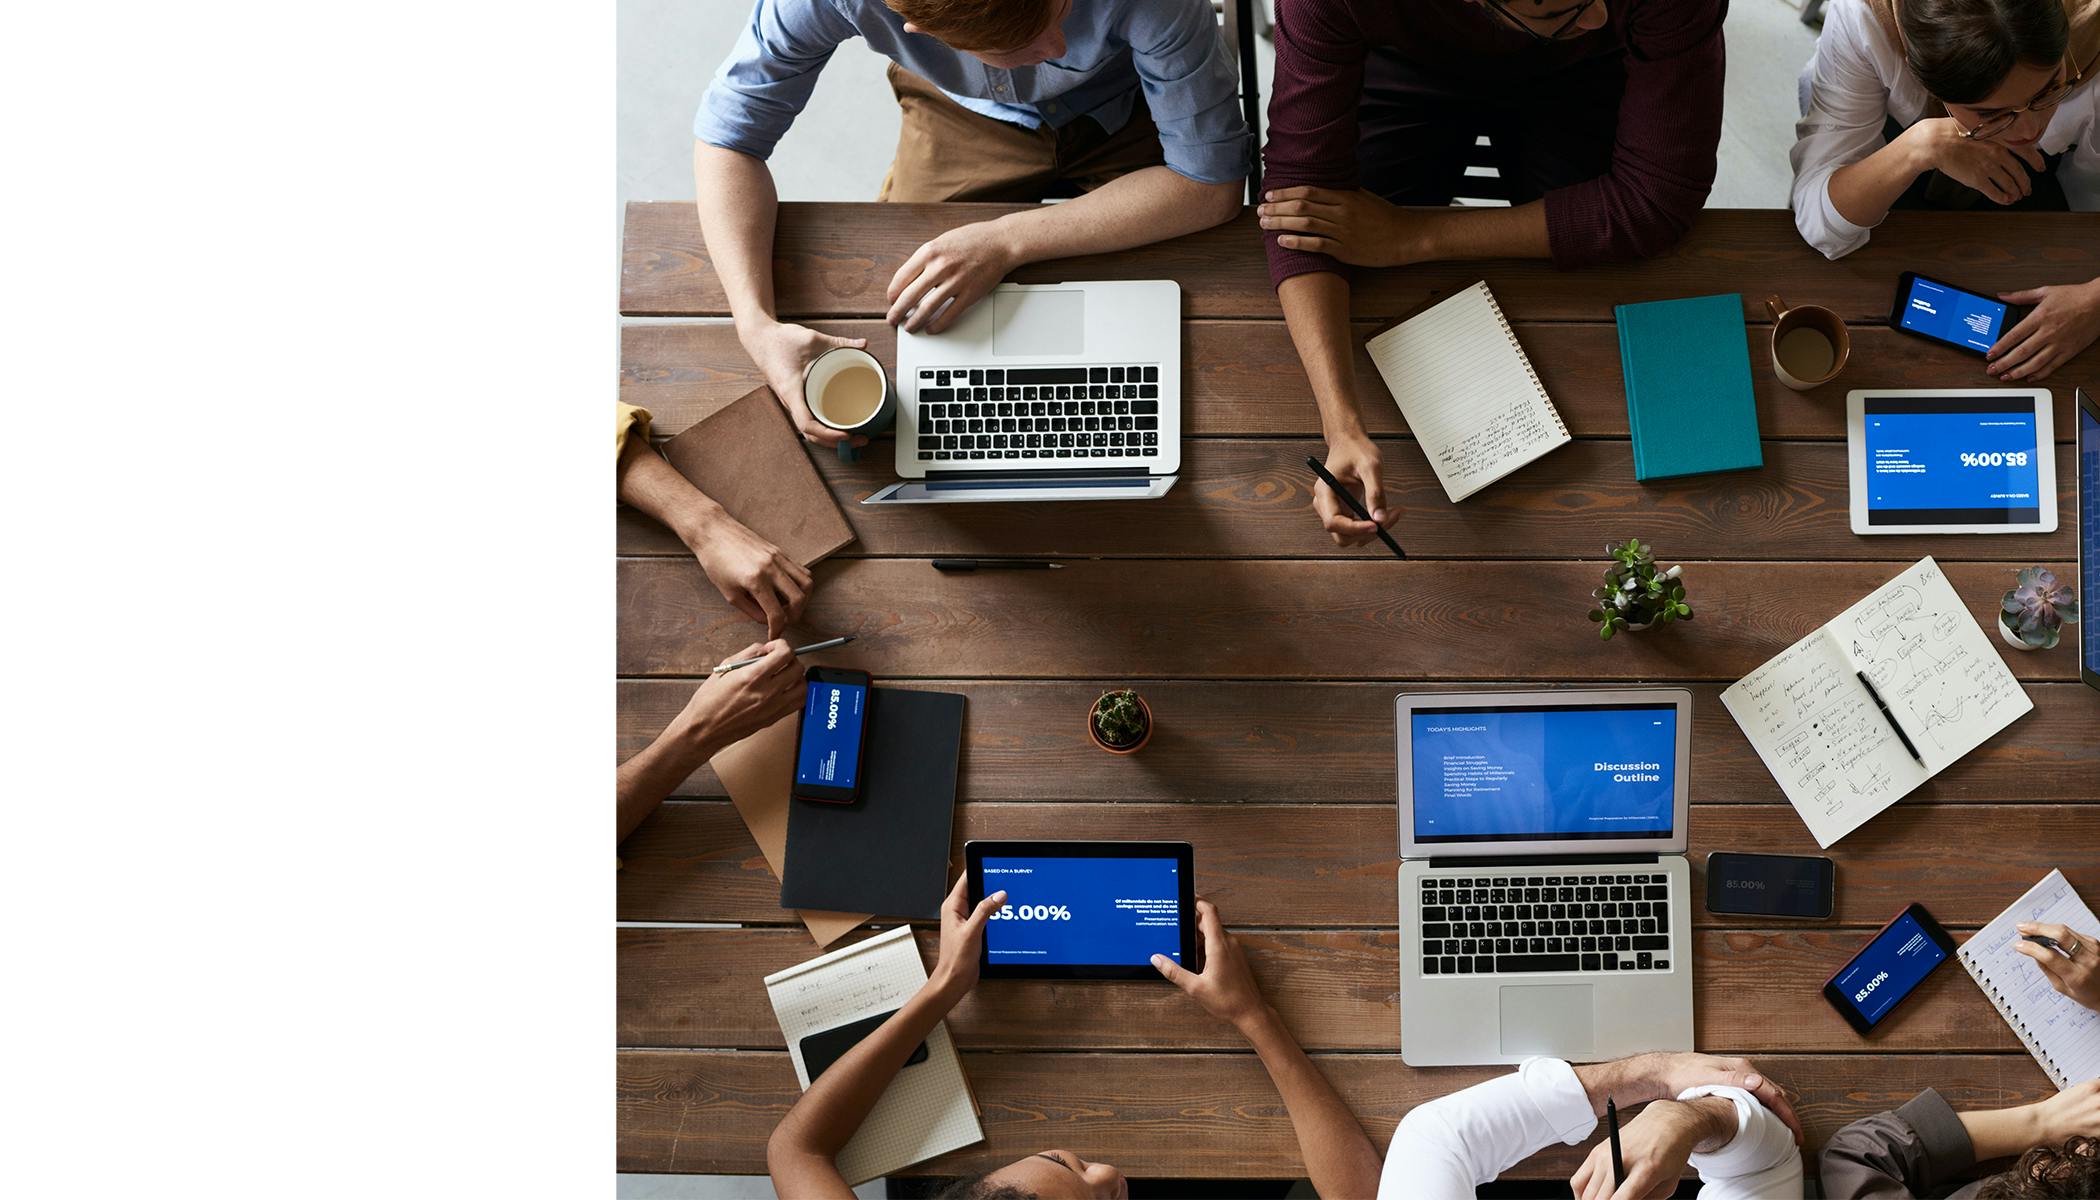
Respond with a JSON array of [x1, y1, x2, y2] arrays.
[[617, 927, 2022, 1053]]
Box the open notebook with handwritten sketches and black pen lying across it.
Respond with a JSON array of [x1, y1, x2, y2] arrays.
[[1720, 557, 2035, 847]]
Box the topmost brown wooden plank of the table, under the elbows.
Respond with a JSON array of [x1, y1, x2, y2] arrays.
[[620, 202, 2100, 324]]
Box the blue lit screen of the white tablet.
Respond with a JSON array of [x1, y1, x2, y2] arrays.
[[1863, 395, 2054, 527]]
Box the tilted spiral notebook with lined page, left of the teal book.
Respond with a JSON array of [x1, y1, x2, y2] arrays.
[[1363, 282, 1571, 504]]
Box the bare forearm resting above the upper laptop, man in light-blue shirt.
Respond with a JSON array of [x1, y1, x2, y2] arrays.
[[991, 166, 1243, 263]]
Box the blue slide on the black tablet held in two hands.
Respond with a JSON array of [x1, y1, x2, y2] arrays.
[[983, 857, 1180, 967]]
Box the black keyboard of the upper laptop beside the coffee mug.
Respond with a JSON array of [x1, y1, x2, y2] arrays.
[[918, 364, 1159, 462]]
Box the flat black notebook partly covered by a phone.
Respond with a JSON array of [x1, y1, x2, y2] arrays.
[[781, 687, 964, 920]]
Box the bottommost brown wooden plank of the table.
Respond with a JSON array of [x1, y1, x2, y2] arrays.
[[617, 1051, 2052, 1179]]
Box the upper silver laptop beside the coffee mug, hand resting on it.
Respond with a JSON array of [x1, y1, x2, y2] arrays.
[[861, 280, 1180, 504]]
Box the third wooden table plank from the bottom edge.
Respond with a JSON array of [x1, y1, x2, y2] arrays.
[[620, 807, 2100, 929]]
